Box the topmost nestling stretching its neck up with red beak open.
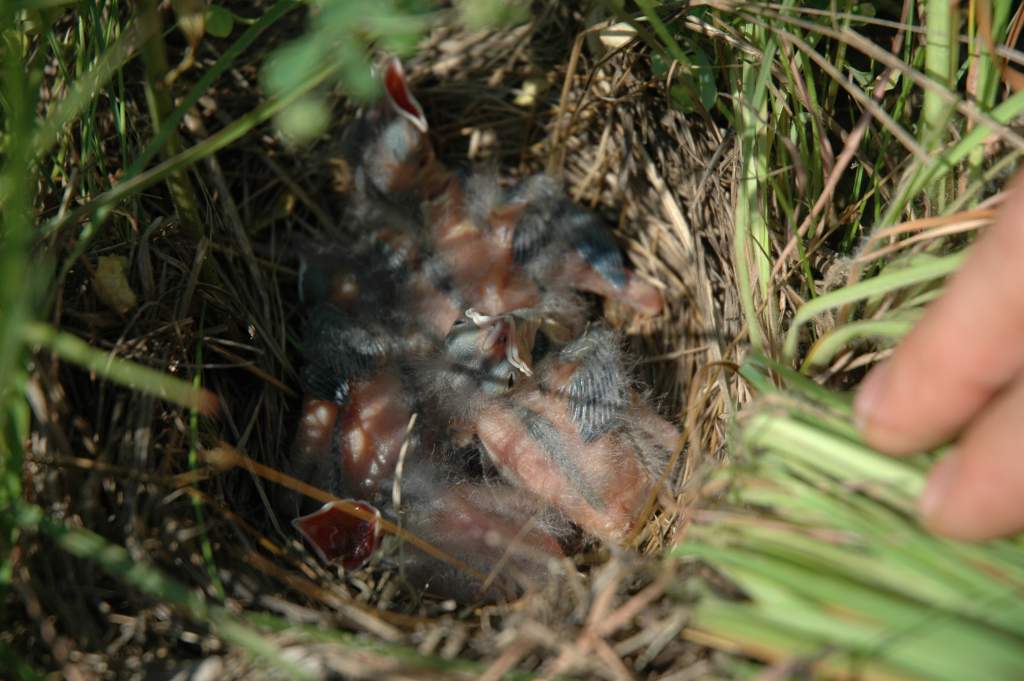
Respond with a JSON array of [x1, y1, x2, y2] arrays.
[[348, 59, 663, 334]]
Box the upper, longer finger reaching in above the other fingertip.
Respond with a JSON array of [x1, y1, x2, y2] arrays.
[[855, 173, 1024, 454]]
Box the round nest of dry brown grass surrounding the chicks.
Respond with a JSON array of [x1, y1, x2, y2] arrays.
[[18, 3, 743, 679]]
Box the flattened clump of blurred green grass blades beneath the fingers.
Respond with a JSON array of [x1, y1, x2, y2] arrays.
[[674, 357, 1024, 681]]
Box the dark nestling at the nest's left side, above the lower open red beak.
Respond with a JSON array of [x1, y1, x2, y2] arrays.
[[291, 238, 421, 513]]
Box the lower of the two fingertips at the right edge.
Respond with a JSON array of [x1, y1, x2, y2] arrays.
[[921, 368, 1024, 540]]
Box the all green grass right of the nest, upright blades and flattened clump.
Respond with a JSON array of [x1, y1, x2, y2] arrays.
[[655, 2, 1024, 681]]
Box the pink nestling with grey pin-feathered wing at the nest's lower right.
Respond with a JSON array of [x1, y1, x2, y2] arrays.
[[434, 315, 681, 542]]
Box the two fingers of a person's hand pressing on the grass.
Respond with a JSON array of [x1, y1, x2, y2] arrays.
[[855, 173, 1024, 541]]
